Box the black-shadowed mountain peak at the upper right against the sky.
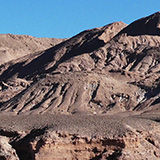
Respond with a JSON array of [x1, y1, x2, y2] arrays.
[[120, 12, 160, 36]]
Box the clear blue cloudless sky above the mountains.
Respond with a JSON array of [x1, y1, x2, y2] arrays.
[[0, 0, 160, 38]]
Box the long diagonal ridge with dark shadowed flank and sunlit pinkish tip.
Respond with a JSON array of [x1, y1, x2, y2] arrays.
[[0, 22, 126, 80]]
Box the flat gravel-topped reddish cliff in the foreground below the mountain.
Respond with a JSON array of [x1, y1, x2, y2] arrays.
[[0, 114, 160, 160]]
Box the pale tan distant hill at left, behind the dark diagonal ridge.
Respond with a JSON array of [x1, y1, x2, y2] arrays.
[[0, 34, 65, 65]]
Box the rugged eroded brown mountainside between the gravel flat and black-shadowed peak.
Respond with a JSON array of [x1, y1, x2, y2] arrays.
[[0, 13, 160, 114]]
